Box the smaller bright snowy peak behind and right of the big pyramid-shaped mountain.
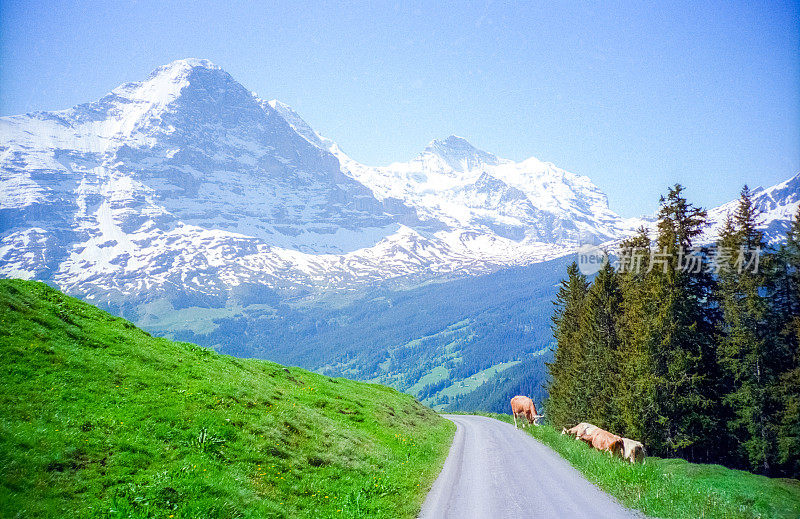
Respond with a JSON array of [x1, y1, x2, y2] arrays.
[[270, 101, 628, 247]]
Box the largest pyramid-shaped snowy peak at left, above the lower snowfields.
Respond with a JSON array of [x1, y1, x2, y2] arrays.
[[0, 60, 408, 248]]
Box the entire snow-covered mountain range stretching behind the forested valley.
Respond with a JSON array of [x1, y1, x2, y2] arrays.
[[0, 59, 798, 306]]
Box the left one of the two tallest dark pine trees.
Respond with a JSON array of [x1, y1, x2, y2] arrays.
[[645, 185, 716, 460]]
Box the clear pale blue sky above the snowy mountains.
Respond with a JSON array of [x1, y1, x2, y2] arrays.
[[0, 0, 800, 216]]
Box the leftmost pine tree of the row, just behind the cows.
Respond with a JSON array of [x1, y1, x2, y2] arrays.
[[547, 262, 589, 427]]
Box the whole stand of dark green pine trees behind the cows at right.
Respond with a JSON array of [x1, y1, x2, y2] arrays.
[[547, 185, 800, 477]]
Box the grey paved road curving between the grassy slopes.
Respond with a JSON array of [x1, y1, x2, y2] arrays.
[[419, 415, 642, 519]]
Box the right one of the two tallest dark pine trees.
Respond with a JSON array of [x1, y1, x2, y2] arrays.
[[717, 186, 780, 473]]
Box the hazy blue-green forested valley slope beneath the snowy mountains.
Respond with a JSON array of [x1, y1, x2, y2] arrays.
[[153, 257, 573, 411]]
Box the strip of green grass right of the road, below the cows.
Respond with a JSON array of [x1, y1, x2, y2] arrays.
[[476, 413, 800, 519]]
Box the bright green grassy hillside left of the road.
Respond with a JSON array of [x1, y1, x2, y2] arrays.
[[0, 280, 454, 518]]
